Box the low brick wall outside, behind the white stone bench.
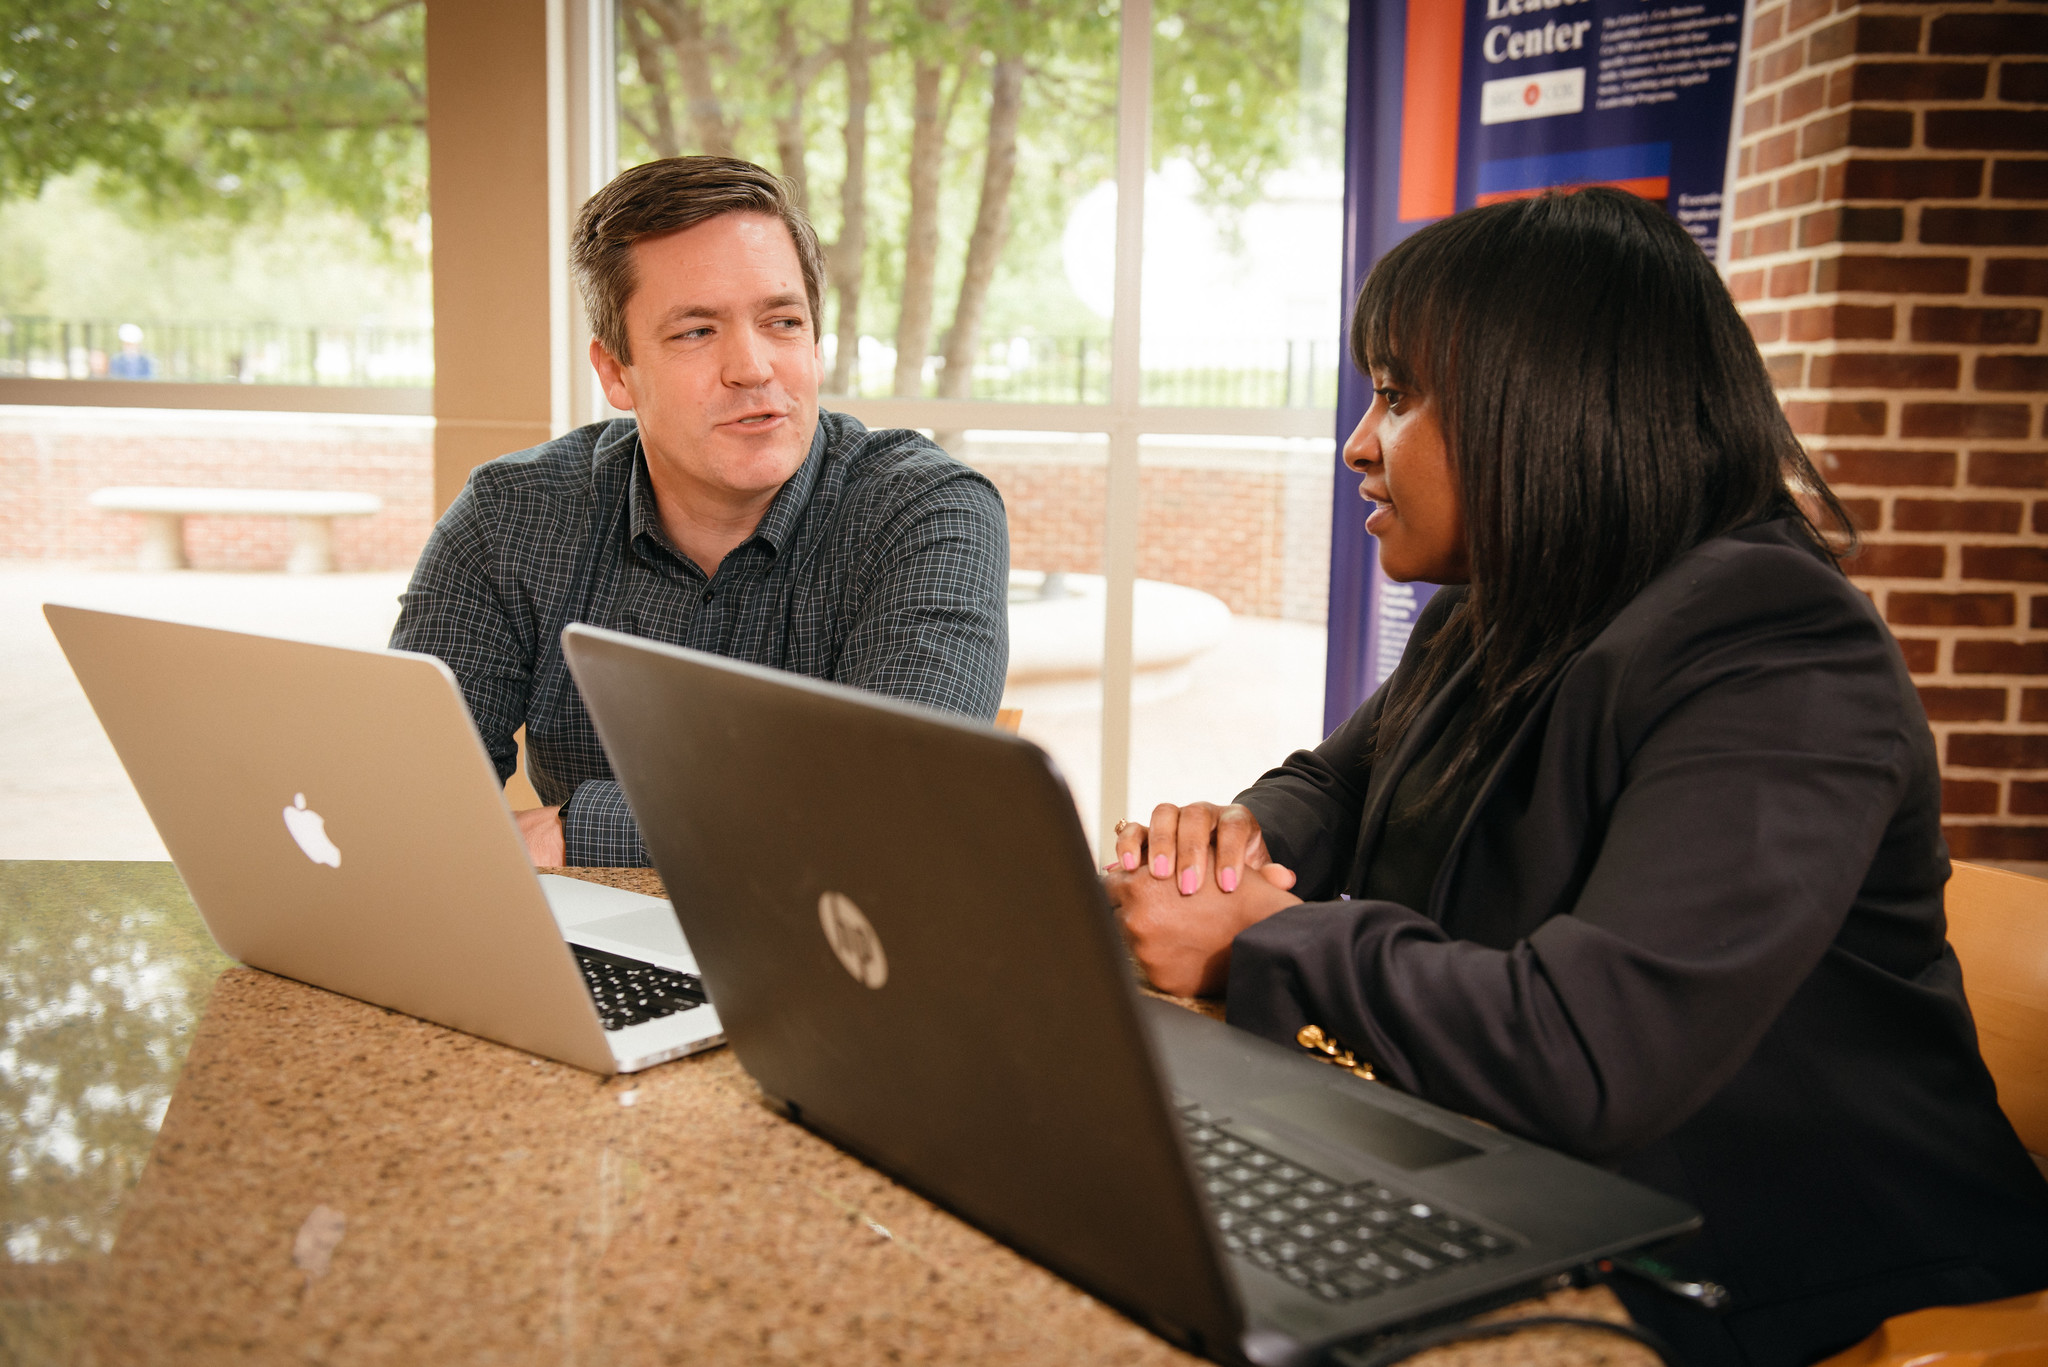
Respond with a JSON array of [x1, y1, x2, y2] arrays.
[[0, 406, 434, 570]]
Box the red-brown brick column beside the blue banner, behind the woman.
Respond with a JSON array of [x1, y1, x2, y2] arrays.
[[1726, 0, 2048, 871]]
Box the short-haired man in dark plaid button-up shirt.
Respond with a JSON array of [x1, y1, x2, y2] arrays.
[[391, 156, 1010, 865]]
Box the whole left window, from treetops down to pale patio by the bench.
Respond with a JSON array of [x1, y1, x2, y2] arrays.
[[0, 0, 434, 859]]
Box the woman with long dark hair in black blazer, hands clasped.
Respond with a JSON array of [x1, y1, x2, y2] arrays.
[[1110, 191, 2048, 1367]]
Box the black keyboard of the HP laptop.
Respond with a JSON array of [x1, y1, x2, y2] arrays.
[[1182, 1105, 1516, 1301]]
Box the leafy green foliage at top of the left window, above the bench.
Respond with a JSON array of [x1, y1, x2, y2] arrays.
[[0, 0, 426, 238]]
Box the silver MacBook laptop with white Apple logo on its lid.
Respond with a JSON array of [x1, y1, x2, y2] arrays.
[[43, 605, 725, 1074]]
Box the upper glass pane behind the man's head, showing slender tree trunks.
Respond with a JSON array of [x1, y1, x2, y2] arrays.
[[618, 0, 1116, 404]]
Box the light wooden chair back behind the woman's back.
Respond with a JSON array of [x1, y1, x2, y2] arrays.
[[1948, 863, 2048, 1156]]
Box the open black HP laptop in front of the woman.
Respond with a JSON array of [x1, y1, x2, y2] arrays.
[[563, 625, 1698, 1363]]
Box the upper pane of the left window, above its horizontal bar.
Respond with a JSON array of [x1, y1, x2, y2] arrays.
[[0, 0, 434, 401]]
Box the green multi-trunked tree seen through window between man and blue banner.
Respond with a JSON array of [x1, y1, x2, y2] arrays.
[[618, 0, 1341, 398]]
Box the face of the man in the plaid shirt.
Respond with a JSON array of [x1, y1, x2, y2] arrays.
[[590, 213, 819, 508]]
